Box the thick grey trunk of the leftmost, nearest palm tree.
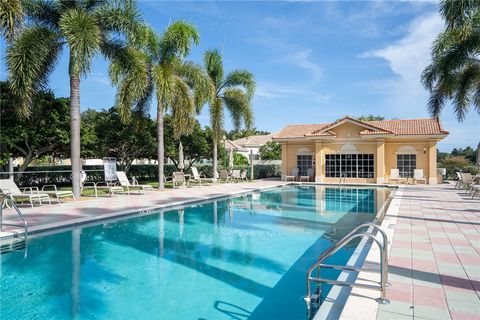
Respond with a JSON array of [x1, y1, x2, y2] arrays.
[[70, 74, 82, 198]]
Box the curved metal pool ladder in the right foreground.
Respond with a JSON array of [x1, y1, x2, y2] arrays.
[[304, 223, 390, 319]]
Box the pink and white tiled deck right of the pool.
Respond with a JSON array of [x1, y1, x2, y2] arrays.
[[341, 184, 480, 320]]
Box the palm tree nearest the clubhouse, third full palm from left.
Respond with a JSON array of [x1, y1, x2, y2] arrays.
[[204, 49, 255, 178]]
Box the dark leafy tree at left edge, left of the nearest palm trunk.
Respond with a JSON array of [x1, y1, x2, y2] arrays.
[[0, 81, 69, 175]]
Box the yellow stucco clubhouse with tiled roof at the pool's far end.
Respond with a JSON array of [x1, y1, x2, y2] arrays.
[[274, 117, 448, 184]]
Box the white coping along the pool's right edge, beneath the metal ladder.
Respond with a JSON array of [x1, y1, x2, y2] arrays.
[[313, 185, 403, 320]]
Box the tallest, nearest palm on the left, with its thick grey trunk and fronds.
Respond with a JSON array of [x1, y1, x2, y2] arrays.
[[0, 0, 139, 197]]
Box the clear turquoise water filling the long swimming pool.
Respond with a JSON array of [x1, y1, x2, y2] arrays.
[[0, 186, 388, 319]]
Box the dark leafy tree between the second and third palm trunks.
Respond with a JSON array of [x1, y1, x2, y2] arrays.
[[164, 115, 212, 170]]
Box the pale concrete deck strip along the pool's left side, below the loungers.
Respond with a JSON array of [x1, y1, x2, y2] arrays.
[[0, 179, 285, 238]]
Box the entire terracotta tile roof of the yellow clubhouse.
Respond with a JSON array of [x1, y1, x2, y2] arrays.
[[274, 117, 448, 139]]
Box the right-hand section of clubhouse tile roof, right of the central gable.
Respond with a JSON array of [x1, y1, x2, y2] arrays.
[[361, 119, 448, 136]]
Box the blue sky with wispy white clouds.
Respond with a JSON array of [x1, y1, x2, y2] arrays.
[[0, 1, 480, 152]]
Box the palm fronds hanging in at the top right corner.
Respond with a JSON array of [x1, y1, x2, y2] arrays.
[[422, 0, 480, 121]]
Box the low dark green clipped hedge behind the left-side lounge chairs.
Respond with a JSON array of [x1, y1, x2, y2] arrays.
[[5, 164, 281, 187]]
